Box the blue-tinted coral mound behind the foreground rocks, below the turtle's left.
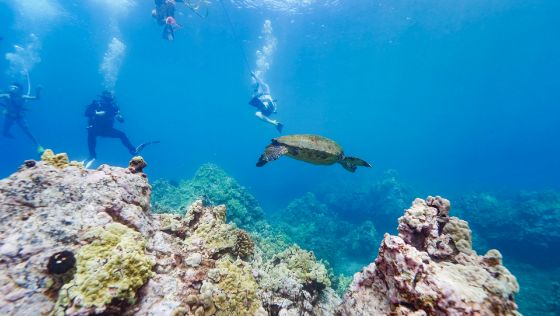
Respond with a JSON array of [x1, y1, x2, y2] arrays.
[[152, 164, 263, 230]]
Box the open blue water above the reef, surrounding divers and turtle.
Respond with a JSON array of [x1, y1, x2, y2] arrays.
[[0, 0, 560, 312]]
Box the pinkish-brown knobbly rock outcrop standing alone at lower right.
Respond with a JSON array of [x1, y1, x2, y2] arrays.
[[337, 197, 519, 315]]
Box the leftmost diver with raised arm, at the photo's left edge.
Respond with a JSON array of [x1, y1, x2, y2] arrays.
[[0, 83, 45, 154]]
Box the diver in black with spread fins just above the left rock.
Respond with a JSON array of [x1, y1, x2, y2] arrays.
[[85, 90, 159, 168]]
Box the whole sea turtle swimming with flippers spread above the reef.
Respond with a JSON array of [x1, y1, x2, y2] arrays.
[[257, 135, 371, 172]]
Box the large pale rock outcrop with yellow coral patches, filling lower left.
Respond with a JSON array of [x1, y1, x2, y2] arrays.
[[0, 154, 340, 316]]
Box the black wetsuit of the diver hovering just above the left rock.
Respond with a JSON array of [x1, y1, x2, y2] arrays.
[[85, 98, 136, 159]]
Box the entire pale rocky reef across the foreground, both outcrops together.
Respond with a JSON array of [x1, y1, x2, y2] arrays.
[[0, 151, 519, 316]]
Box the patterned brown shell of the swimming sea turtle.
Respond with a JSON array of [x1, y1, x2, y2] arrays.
[[272, 135, 344, 165]]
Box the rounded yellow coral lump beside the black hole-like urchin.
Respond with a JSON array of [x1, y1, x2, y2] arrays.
[[56, 223, 154, 313]]
